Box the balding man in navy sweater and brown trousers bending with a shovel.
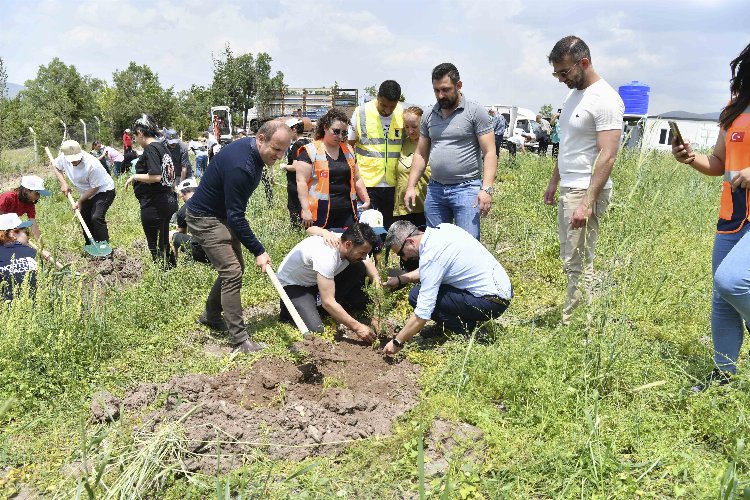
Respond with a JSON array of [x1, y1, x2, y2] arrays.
[[185, 121, 292, 353]]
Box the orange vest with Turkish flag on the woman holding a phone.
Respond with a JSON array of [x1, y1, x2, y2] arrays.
[[716, 110, 750, 234]]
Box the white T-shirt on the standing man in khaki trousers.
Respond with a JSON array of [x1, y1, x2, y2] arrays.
[[557, 80, 625, 189]]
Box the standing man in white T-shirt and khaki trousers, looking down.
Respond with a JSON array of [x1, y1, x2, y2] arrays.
[[544, 36, 625, 324]]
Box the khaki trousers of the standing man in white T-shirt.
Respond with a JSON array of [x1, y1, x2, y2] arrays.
[[557, 187, 612, 323]]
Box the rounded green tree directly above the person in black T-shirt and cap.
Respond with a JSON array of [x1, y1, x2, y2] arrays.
[[106, 61, 177, 142]]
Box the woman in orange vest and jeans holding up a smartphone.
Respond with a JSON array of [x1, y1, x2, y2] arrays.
[[672, 45, 750, 392]]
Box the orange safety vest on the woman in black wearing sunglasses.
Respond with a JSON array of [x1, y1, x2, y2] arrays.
[[302, 140, 357, 227]]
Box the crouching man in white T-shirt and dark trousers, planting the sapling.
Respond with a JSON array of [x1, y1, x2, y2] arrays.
[[278, 223, 380, 342]]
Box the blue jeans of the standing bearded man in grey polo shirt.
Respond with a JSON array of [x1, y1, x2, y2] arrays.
[[424, 179, 482, 239]]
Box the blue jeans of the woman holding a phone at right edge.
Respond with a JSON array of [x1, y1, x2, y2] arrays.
[[711, 222, 750, 373]]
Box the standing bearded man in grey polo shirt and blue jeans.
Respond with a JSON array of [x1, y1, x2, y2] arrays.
[[404, 63, 497, 239]]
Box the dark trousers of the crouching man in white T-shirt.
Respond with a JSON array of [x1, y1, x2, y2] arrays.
[[279, 262, 370, 333]]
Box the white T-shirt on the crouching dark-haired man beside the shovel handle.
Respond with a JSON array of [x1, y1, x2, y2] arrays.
[[277, 233, 349, 286]]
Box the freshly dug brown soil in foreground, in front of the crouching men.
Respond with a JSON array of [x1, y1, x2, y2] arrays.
[[111, 338, 419, 471]]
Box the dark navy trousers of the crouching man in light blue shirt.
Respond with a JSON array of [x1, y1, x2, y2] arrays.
[[409, 285, 510, 335]]
